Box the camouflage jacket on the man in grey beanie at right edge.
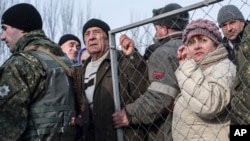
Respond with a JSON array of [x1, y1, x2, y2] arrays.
[[231, 26, 250, 124]]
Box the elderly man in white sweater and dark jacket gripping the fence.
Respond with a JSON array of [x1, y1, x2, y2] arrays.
[[78, 19, 148, 141]]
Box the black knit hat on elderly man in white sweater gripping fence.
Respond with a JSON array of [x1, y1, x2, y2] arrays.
[[82, 19, 110, 38]]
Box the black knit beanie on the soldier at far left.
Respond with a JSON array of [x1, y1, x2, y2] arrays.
[[1, 3, 42, 32]]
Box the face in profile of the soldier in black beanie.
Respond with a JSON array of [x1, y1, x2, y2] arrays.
[[1, 24, 25, 53]]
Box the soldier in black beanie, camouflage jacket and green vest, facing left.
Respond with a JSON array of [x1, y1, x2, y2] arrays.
[[0, 3, 76, 141]]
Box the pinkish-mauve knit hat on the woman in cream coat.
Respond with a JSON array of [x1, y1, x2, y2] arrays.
[[182, 19, 222, 45]]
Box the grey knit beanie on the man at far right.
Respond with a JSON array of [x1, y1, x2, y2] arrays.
[[217, 5, 245, 26]]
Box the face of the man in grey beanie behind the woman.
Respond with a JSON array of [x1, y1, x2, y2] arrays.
[[220, 20, 245, 41]]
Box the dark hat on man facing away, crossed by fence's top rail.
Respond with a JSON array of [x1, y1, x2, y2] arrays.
[[154, 3, 189, 31]]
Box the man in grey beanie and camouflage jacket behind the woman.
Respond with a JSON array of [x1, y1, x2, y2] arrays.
[[217, 5, 250, 125]]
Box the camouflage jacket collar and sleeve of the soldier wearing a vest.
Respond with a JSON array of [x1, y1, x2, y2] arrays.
[[0, 30, 67, 141]]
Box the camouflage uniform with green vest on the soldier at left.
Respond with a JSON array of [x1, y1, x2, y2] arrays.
[[0, 30, 76, 141]]
